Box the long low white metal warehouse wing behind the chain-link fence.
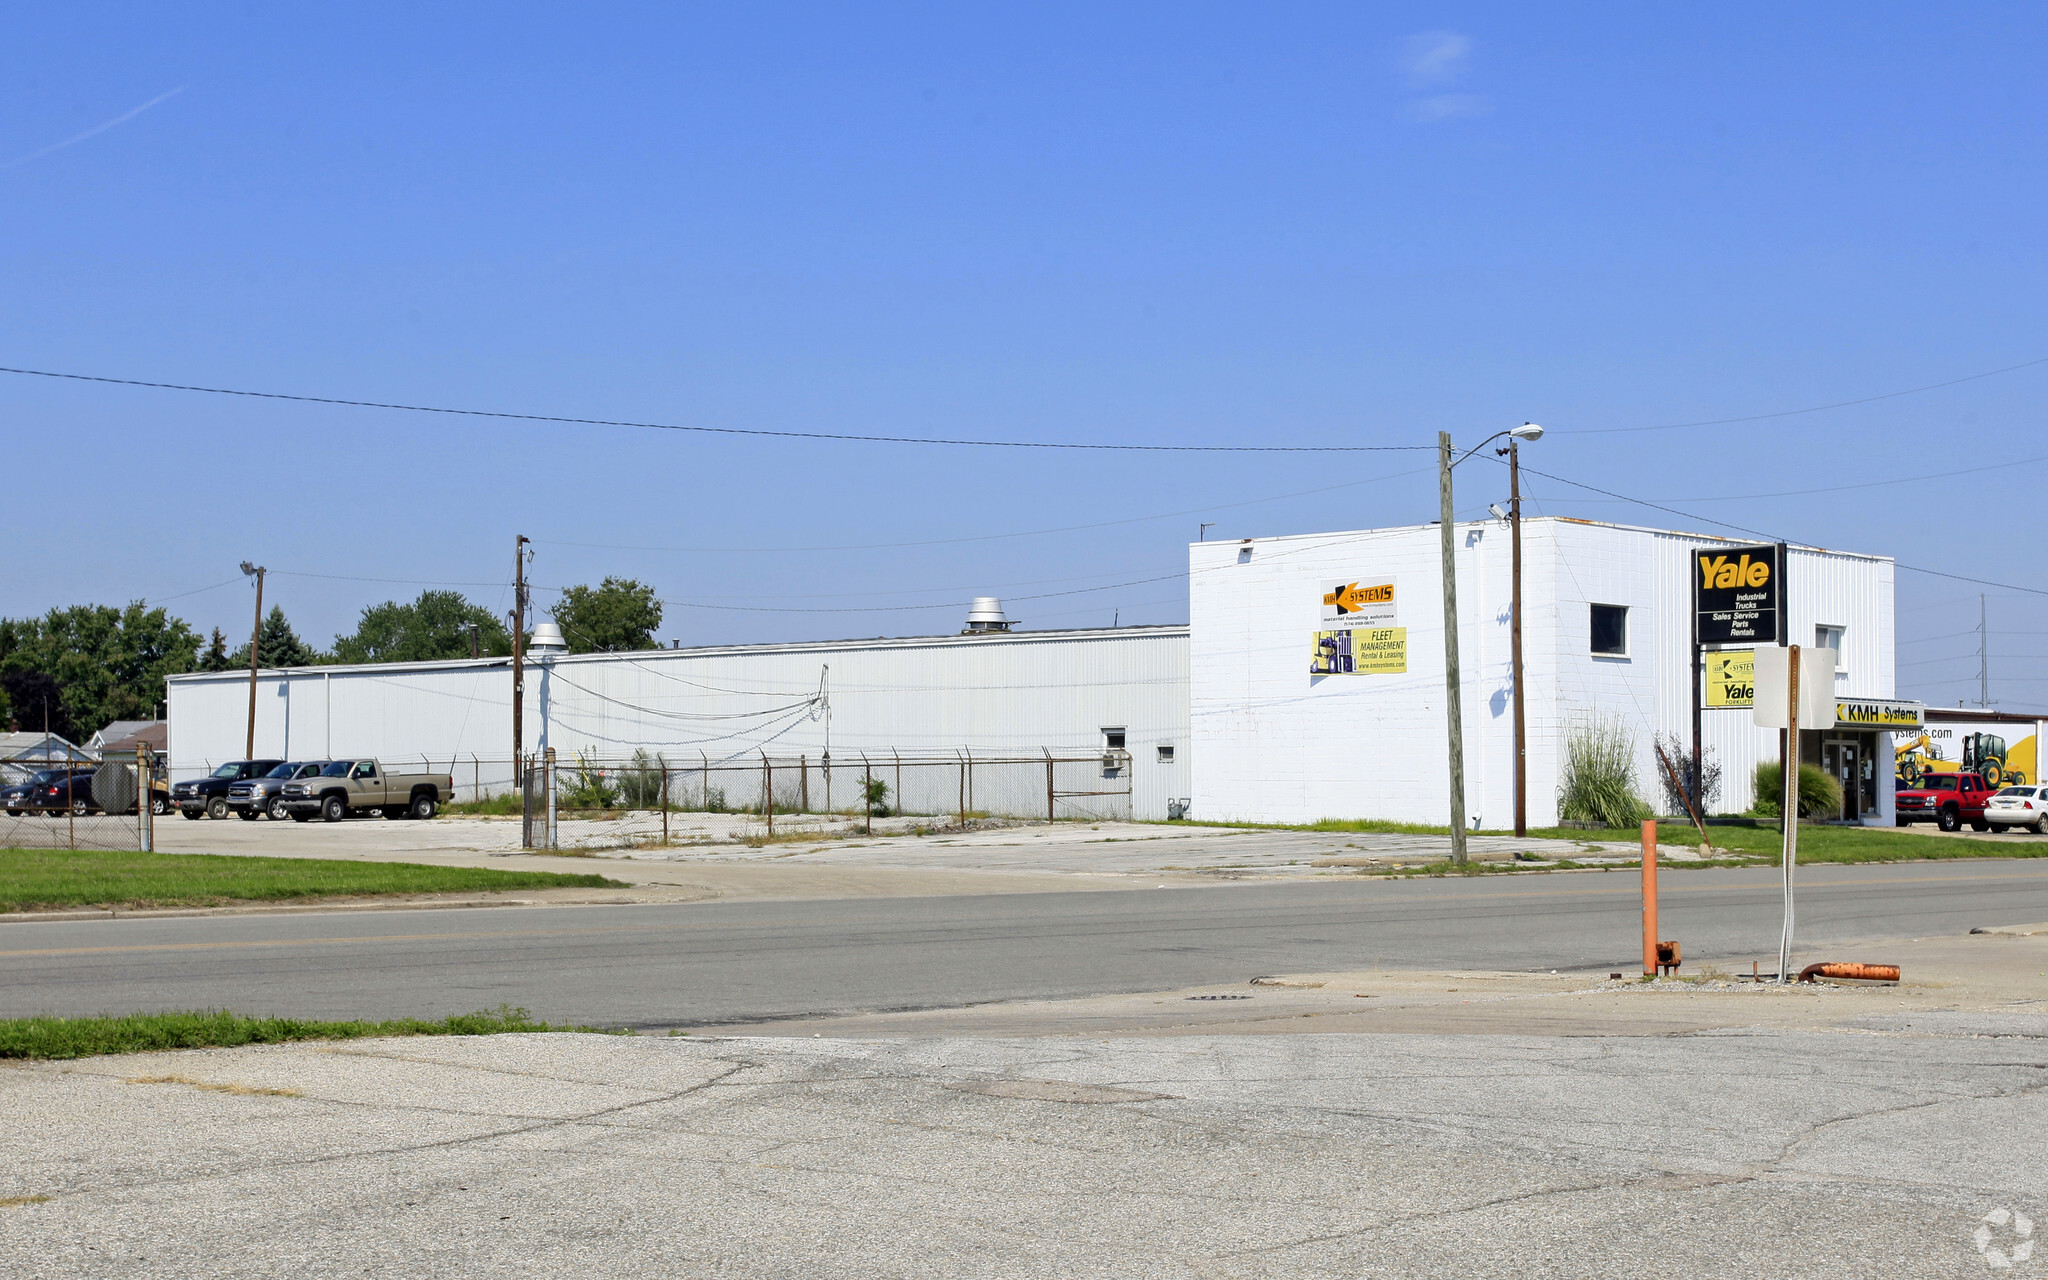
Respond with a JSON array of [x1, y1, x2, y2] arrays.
[[170, 618, 1190, 817]]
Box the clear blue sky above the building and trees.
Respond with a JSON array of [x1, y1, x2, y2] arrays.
[[0, 4, 2048, 709]]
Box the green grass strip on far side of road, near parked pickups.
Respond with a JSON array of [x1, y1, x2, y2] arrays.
[[0, 850, 625, 911]]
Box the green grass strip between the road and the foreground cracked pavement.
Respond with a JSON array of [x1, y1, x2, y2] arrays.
[[0, 1006, 600, 1059]]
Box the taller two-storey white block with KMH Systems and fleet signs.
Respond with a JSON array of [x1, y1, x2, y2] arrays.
[[1188, 518, 1919, 831]]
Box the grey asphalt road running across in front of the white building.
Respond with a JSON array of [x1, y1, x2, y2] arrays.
[[0, 860, 2048, 1026]]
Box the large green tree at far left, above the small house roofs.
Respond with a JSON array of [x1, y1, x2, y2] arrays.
[[0, 600, 199, 741]]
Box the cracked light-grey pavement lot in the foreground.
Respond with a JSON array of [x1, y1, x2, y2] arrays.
[[0, 978, 2048, 1280]]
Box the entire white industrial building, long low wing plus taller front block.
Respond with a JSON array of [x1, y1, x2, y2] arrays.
[[170, 518, 1916, 831]]
